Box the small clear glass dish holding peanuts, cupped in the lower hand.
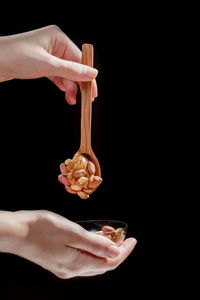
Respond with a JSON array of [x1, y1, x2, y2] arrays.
[[76, 220, 128, 246]]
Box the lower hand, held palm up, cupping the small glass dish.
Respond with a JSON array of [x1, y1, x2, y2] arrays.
[[0, 211, 136, 278]]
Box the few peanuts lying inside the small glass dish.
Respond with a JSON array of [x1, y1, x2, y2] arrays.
[[95, 226, 125, 244]]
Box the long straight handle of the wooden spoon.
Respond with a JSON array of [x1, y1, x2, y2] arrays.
[[80, 44, 93, 153]]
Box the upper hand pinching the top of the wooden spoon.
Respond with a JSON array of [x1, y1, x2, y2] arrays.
[[0, 25, 97, 104]]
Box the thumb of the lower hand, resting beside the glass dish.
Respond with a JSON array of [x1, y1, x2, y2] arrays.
[[68, 230, 120, 258]]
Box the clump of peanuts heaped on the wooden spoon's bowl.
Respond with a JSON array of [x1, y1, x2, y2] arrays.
[[58, 152, 102, 199]]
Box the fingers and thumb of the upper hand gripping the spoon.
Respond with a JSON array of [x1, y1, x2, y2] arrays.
[[45, 26, 98, 105]]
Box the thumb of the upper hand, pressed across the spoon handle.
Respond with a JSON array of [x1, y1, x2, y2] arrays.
[[47, 53, 98, 82]]
